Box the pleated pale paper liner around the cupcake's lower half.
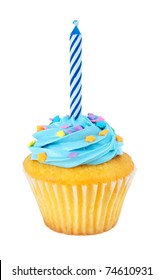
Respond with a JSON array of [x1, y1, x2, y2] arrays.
[[26, 171, 135, 235]]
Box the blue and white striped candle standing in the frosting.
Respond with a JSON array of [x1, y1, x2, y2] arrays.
[[70, 20, 82, 119]]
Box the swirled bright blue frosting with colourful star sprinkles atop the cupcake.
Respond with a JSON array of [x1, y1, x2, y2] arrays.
[[28, 114, 123, 168]]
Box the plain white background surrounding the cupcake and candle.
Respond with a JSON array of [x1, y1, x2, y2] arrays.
[[0, 0, 163, 280]]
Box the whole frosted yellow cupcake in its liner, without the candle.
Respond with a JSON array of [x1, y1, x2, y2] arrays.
[[24, 113, 134, 235]]
